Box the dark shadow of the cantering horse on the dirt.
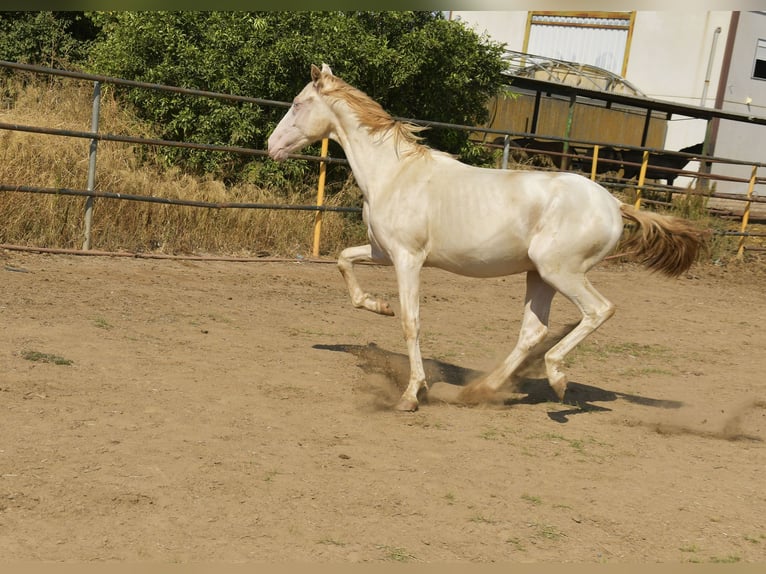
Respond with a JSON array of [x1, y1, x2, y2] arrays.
[[313, 343, 683, 423]]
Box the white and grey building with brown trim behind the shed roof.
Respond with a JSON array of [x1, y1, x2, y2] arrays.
[[449, 10, 766, 193]]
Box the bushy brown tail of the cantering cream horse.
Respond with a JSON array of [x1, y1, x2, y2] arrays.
[[620, 203, 707, 277]]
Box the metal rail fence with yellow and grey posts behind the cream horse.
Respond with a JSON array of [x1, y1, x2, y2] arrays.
[[0, 61, 766, 257]]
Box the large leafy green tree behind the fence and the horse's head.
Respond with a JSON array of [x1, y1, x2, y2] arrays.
[[90, 11, 504, 184]]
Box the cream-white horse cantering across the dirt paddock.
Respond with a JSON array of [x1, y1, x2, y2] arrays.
[[268, 64, 705, 411]]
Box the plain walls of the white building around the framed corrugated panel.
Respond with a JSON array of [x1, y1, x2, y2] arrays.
[[450, 10, 766, 193]]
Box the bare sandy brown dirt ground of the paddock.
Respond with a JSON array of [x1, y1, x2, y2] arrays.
[[0, 251, 766, 563]]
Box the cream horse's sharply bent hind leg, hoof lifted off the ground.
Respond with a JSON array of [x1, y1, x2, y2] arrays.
[[544, 271, 614, 401]]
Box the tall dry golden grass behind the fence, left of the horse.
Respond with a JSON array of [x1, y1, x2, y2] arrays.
[[0, 80, 364, 257]]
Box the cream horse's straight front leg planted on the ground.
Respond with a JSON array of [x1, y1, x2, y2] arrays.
[[394, 255, 428, 411]]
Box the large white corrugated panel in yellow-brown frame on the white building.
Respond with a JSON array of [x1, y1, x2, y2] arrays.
[[524, 12, 636, 76]]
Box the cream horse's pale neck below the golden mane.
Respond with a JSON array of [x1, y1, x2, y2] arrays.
[[334, 112, 414, 198]]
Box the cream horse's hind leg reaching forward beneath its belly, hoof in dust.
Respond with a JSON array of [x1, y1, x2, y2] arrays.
[[460, 271, 556, 402]]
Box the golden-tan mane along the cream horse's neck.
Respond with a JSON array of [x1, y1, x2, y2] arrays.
[[321, 76, 434, 159]]
